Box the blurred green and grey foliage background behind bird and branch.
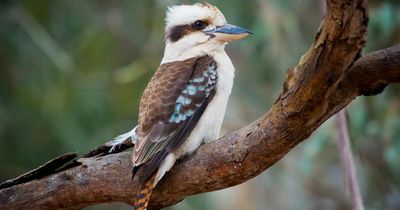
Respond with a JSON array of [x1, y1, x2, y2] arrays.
[[0, 0, 400, 210]]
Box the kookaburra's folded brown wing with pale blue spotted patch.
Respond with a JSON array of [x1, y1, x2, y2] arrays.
[[132, 56, 217, 180]]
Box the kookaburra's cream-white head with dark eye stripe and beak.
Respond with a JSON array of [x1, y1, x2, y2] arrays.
[[164, 3, 251, 62]]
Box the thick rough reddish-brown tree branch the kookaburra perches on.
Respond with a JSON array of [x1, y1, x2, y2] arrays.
[[0, 0, 400, 209]]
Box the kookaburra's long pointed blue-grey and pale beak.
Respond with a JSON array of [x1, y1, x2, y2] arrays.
[[204, 24, 253, 42]]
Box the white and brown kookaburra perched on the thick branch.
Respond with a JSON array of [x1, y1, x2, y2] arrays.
[[113, 3, 251, 210]]
